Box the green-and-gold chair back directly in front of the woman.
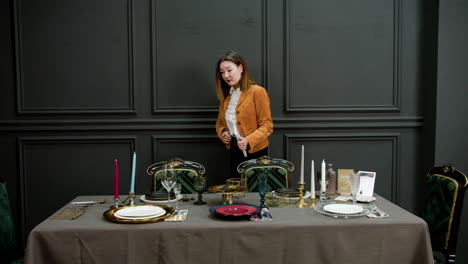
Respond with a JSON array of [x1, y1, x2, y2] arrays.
[[237, 156, 294, 192]]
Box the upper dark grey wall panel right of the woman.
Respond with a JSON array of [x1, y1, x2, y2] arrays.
[[285, 0, 399, 111]]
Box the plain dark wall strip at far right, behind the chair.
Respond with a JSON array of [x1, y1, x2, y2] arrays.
[[433, 0, 468, 263]]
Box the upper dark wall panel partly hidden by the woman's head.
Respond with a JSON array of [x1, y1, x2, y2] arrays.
[[152, 0, 266, 112]]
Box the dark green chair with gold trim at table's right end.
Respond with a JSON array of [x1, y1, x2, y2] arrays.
[[422, 164, 468, 263]]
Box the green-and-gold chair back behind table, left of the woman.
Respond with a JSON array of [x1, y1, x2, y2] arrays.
[[146, 158, 205, 193]]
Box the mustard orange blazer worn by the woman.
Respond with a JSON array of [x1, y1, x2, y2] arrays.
[[216, 85, 273, 153]]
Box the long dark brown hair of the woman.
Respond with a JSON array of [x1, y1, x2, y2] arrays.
[[215, 50, 255, 102]]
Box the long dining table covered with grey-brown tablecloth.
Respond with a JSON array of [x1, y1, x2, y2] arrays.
[[25, 193, 433, 264]]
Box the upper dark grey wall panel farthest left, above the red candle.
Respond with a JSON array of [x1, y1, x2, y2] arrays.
[[15, 0, 133, 114]]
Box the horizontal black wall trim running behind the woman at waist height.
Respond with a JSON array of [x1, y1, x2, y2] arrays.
[[0, 116, 423, 133]]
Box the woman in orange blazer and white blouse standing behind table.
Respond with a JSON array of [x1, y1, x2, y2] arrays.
[[216, 51, 273, 178]]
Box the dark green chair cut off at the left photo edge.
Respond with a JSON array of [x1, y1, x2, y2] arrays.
[[0, 177, 23, 263]]
